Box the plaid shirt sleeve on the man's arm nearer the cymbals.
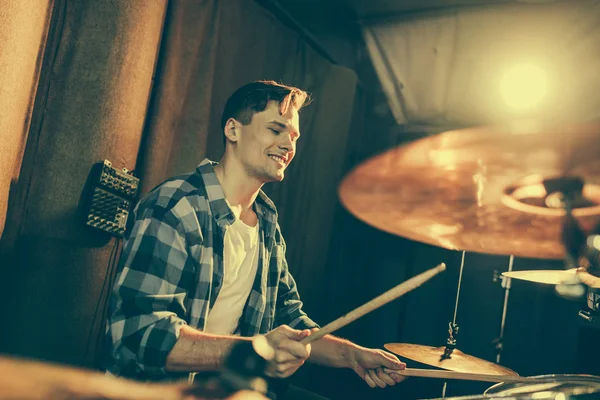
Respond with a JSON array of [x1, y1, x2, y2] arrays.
[[273, 237, 319, 329]]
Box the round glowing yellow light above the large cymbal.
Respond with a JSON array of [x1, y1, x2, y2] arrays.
[[500, 64, 547, 110]]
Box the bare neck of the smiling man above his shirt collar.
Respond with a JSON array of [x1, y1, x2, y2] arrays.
[[215, 155, 263, 218]]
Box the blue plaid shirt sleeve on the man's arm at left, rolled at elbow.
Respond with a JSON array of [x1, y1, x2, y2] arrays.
[[108, 198, 196, 378]]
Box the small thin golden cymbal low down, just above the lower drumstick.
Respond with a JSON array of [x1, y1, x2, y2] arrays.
[[384, 343, 519, 376]]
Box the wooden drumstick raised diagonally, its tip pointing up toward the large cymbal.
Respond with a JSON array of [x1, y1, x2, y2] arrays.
[[300, 263, 446, 345]]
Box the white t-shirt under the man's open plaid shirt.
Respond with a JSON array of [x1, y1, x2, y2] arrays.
[[204, 218, 258, 335]]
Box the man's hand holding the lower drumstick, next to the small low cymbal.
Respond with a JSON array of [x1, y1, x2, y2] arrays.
[[350, 346, 406, 388]]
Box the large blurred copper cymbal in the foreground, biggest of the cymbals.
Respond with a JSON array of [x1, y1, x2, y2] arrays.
[[339, 121, 600, 259]]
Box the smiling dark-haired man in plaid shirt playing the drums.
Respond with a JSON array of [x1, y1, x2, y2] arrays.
[[108, 81, 405, 396]]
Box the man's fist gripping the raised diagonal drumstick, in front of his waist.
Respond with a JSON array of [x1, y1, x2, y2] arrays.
[[265, 325, 310, 378]]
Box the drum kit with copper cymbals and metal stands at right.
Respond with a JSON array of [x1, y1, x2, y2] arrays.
[[339, 120, 600, 400]]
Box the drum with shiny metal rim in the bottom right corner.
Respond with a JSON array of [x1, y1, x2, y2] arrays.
[[484, 375, 600, 400]]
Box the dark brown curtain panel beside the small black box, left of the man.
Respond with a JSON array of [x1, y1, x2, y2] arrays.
[[0, 0, 166, 365]]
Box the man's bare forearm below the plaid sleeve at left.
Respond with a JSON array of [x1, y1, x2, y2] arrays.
[[165, 325, 251, 372]]
